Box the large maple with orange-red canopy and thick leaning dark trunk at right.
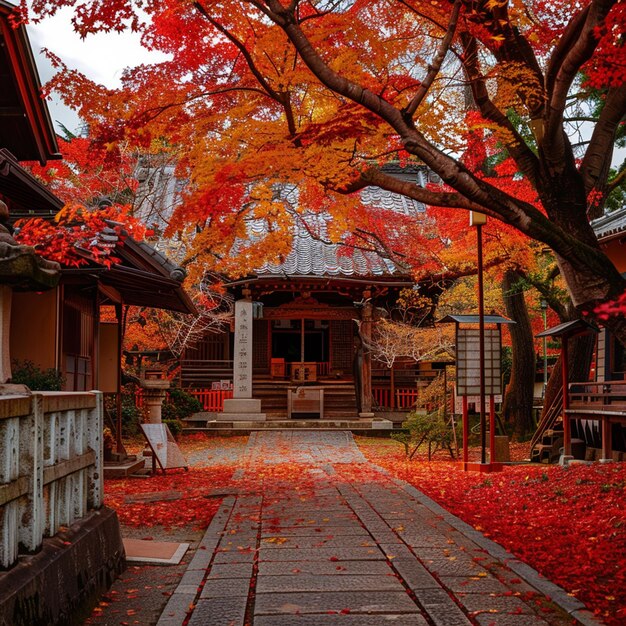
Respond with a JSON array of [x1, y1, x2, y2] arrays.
[[26, 0, 626, 342]]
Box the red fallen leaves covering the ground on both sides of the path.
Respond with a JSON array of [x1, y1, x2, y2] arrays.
[[98, 435, 626, 626]]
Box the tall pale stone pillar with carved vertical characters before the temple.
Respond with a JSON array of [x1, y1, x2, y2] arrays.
[[219, 298, 265, 422]]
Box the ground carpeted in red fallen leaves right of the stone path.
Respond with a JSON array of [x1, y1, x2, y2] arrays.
[[357, 437, 626, 626]]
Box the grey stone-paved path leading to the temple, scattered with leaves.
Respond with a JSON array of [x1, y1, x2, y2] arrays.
[[158, 431, 600, 626]]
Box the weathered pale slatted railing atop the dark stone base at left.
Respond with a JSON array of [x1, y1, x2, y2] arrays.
[[0, 392, 103, 568]]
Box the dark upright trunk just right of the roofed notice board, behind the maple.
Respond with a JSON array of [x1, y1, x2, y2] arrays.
[[502, 270, 537, 437]]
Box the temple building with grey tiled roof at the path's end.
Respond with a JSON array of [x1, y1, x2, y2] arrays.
[[162, 166, 444, 421]]
